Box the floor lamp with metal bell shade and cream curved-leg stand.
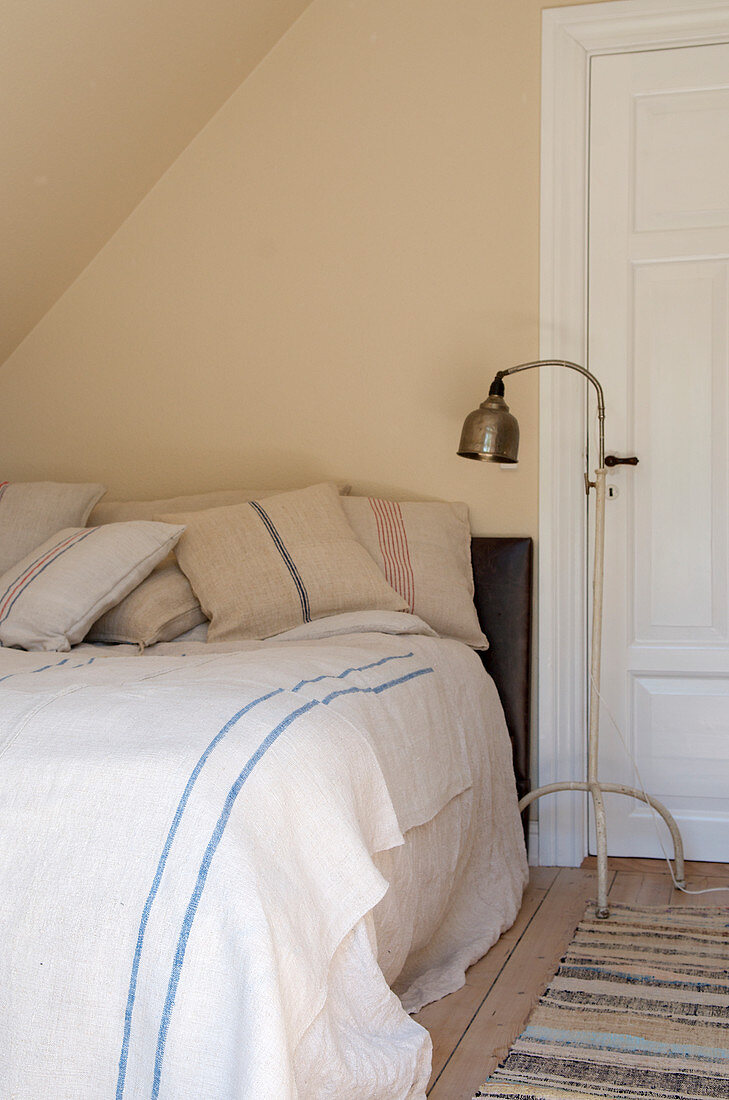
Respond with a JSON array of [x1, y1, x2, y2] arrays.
[[459, 359, 685, 917]]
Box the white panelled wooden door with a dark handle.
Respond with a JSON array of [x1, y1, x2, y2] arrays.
[[588, 44, 729, 860]]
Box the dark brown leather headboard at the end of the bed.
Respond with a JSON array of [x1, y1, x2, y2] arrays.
[[471, 538, 532, 814]]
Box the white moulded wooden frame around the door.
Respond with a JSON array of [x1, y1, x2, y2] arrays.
[[538, 0, 729, 866]]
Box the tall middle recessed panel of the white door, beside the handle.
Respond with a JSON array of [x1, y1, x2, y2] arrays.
[[630, 261, 729, 646]]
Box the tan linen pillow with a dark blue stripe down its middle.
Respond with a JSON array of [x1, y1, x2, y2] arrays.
[[161, 485, 405, 641]]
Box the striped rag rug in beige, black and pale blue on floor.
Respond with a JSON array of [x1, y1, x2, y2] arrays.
[[474, 903, 729, 1100]]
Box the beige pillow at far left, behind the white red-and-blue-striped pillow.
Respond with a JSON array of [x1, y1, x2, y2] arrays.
[[0, 482, 106, 574]]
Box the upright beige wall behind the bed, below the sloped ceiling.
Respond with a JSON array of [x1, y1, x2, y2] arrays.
[[0, 0, 602, 534]]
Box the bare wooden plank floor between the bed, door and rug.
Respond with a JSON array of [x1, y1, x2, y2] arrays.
[[416, 857, 729, 1100]]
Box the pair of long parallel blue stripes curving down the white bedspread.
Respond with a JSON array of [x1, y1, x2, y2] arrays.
[[117, 652, 433, 1100]]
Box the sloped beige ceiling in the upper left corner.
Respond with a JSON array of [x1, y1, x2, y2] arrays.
[[0, 0, 310, 363]]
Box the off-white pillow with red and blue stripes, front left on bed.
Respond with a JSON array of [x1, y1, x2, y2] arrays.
[[0, 521, 183, 650]]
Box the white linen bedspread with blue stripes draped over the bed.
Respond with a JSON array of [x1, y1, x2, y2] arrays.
[[0, 615, 526, 1100]]
